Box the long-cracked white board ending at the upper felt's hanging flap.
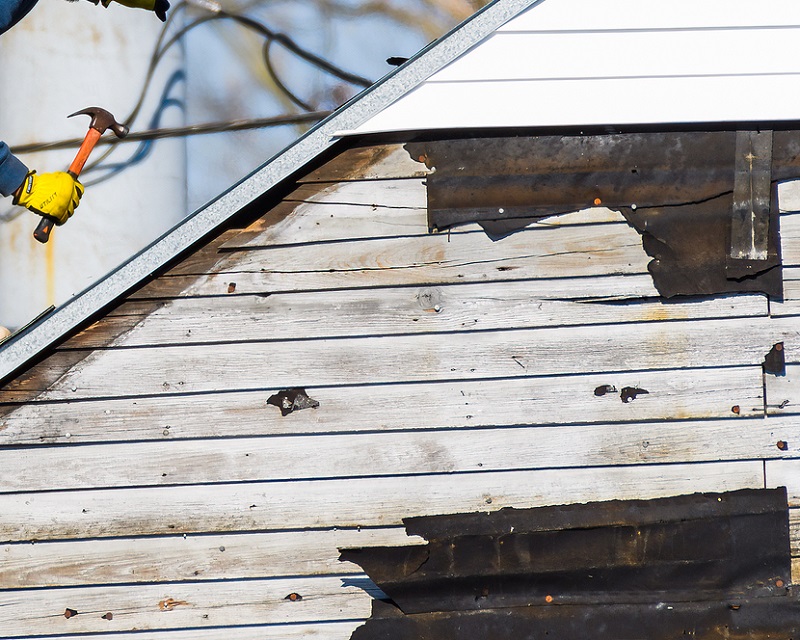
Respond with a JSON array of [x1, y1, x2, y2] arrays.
[[169, 224, 650, 290]]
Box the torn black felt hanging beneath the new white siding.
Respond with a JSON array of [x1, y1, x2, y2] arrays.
[[406, 130, 800, 299]]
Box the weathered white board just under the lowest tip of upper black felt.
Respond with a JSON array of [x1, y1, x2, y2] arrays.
[[81, 290, 768, 347]]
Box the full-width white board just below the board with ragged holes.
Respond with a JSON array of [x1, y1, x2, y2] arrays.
[[0, 418, 800, 493]]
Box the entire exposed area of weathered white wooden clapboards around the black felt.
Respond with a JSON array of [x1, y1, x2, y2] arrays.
[[0, 144, 800, 640]]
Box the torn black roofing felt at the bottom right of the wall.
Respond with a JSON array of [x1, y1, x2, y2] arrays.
[[340, 488, 800, 640]]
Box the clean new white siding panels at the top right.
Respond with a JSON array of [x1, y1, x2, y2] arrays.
[[355, 0, 800, 133]]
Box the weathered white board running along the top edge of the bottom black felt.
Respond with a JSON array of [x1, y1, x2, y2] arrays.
[[0, 462, 764, 543]]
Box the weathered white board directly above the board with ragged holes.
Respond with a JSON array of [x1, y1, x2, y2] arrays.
[[31, 317, 800, 400]]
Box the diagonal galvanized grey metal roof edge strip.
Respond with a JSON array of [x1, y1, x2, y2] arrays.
[[0, 0, 545, 383]]
